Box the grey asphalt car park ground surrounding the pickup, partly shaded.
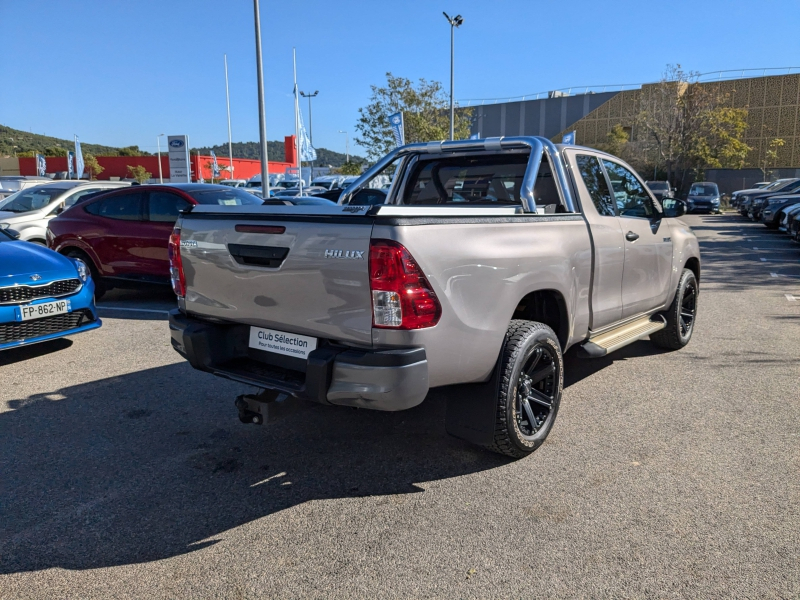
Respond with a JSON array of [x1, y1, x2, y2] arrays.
[[0, 215, 800, 598]]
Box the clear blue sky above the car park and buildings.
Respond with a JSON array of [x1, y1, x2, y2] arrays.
[[0, 0, 800, 152]]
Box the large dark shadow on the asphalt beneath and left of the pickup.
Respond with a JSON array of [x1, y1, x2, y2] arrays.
[[0, 363, 510, 574]]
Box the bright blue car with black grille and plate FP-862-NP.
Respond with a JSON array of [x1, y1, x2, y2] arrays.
[[0, 229, 102, 350]]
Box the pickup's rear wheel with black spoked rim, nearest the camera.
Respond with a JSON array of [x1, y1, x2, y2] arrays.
[[487, 320, 564, 458]]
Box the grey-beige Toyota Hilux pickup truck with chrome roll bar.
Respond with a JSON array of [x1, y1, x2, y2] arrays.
[[170, 137, 700, 457]]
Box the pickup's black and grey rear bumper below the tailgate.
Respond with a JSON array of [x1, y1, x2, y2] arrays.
[[169, 309, 428, 411]]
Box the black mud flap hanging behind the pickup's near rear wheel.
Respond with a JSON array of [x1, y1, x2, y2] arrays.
[[441, 360, 500, 446]]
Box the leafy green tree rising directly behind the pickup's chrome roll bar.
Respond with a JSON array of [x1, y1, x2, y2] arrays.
[[355, 73, 472, 159]]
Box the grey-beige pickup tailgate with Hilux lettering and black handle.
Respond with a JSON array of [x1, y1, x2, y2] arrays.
[[179, 207, 372, 346]]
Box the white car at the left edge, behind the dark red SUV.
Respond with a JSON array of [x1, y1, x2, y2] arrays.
[[0, 180, 130, 246]]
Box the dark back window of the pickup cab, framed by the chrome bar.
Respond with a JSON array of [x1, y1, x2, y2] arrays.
[[403, 154, 528, 205]]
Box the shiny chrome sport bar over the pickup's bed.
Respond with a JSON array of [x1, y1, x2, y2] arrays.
[[339, 136, 575, 213]]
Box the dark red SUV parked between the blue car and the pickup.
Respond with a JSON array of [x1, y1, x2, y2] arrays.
[[47, 183, 263, 298]]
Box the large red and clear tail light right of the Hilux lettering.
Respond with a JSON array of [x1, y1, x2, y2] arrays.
[[369, 240, 442, 329]]
